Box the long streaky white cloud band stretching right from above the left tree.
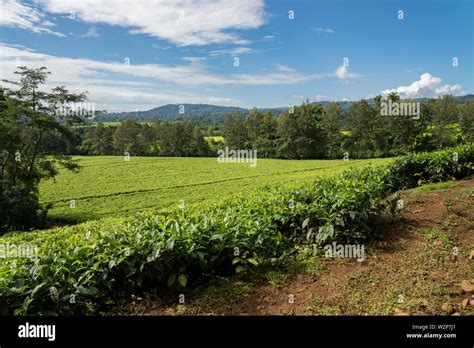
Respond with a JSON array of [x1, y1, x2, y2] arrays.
[[0, 44, 334, 87]]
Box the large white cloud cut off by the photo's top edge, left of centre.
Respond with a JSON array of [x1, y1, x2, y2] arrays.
[[36, 0, 266, 46]]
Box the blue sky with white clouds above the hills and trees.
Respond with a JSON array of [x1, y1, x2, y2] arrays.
[[0, 0, 474, 112]]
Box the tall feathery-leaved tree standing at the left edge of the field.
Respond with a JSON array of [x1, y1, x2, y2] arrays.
[[0, 67, 86, 231]]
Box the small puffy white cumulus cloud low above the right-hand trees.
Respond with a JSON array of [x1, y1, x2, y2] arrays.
[[381, 73, 461, 98]]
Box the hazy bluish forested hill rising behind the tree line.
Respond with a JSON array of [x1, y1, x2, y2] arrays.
[[97, 94, 474, 125]]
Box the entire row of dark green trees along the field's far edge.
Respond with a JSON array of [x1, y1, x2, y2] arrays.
[[40, 94, 474, 159]]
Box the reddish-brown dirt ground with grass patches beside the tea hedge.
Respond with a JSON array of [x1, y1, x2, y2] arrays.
[[121, 179, 474, 315]]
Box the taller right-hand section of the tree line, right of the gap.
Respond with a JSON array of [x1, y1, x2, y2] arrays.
[[223, 94, 474, 159]]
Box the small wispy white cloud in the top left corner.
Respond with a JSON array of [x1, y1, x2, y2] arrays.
[[0, 0, 66, 37]]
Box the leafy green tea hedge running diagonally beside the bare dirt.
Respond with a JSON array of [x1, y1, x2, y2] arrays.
[[0, 145, 474, 315]]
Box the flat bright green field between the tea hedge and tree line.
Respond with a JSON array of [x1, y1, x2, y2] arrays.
[[40, 156, 389, 221]]
